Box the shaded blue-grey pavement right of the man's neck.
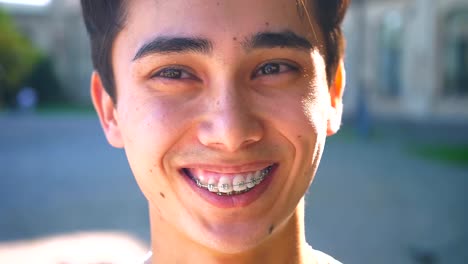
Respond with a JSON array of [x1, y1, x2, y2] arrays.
[[307, 136, 468, 264]]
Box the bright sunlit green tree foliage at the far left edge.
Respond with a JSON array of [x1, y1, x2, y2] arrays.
[[0, 9, 41, 106]]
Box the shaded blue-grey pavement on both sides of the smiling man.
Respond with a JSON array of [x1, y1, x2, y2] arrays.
[[0, 115, 468, 264]]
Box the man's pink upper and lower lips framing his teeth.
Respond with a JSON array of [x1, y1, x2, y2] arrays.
[[180, 162, 279, 209]]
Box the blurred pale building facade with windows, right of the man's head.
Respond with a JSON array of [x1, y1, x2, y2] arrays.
[[345, 0, 468, 120]]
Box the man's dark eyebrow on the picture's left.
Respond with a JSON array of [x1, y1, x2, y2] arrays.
[[133, 37, 213, 61]]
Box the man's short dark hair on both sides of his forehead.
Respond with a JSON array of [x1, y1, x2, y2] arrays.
[[81, 0, 350, 103]]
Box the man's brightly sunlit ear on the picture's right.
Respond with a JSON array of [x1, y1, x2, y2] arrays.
[[327, 60, 346, 136]]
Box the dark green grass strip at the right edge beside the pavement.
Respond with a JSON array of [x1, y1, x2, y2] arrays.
[[411, 144, 468, 166]]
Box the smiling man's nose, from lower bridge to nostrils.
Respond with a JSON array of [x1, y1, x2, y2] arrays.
[[198, 89, 264, 152]]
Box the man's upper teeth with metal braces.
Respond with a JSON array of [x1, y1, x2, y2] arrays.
[[193, 166, 271, 195]]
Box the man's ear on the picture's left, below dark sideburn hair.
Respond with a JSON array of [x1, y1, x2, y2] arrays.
[[91, 71, 123, 148]]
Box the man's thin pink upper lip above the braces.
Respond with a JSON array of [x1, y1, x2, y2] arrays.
[[181, 161, 275, 173]]
